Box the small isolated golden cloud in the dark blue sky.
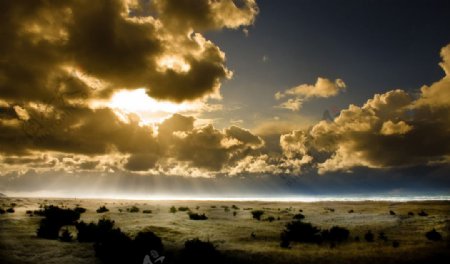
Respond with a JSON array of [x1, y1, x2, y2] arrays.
[[275, 77, 346, 111]]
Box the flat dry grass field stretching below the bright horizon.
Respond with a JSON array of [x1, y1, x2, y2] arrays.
[[0, 198, 450, 264]]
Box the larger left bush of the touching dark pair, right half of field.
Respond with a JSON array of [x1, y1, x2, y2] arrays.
[[281, 221, 322, 243]]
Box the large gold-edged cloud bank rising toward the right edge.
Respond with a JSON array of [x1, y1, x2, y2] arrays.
[[282, 46, 450, 174]]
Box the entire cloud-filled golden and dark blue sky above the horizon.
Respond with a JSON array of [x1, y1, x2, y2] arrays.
[[0, 0, 450, 197]]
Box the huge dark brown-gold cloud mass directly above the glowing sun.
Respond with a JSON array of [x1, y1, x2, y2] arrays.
[[0, 0, 257, 102]]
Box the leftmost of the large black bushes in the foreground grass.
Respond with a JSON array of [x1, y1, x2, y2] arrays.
[[35, 205, 80, 239]]
